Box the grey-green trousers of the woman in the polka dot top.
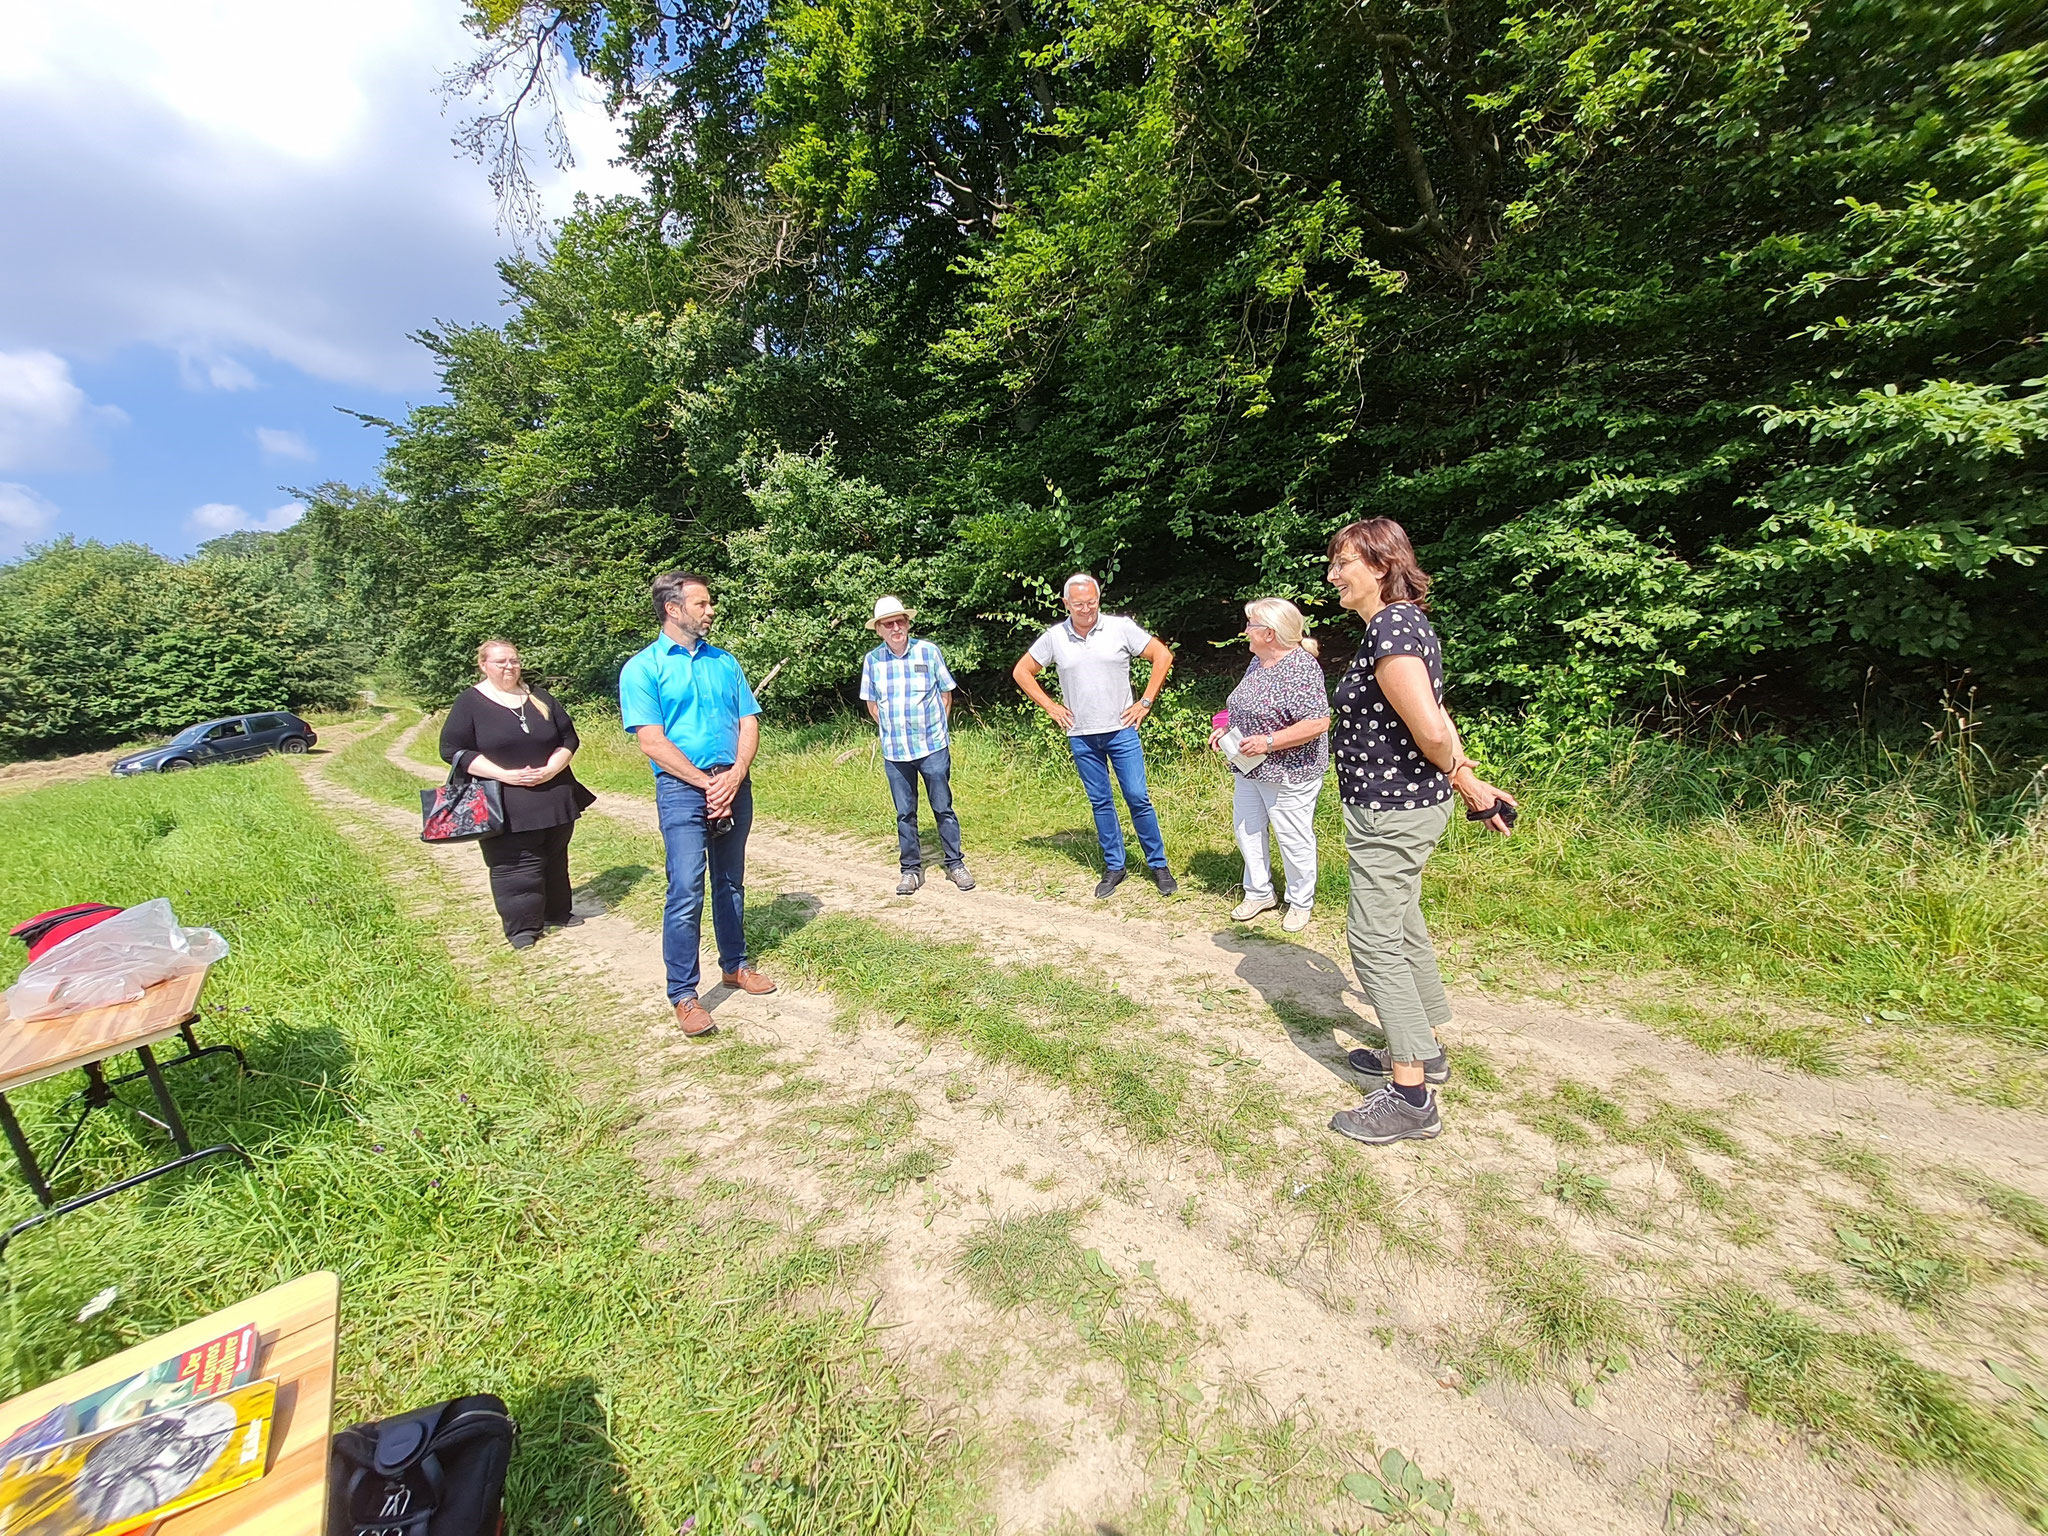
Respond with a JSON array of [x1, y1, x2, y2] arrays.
[[1343, 801, 1454, 1061]]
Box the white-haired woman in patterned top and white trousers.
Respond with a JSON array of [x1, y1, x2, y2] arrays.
[[1208, 598, 1329, 934]]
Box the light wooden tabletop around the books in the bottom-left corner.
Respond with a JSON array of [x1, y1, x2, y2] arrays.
[[0, 1270, 342, 1536]]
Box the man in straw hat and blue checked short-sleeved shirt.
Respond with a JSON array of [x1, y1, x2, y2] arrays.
[[860, 596, 975, 895]]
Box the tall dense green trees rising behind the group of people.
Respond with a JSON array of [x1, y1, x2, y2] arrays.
[[159, 0, 2048, 741]]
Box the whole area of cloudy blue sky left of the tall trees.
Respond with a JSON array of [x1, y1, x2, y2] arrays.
[[0, 0, 633, 559]]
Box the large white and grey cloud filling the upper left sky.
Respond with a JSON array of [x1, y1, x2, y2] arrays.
[[0, 0, 635, 391]]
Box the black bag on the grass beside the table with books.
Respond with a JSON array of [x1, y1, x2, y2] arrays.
[[328, 1393, 518, 1536]]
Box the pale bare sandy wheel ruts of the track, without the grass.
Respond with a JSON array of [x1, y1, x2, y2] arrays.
[[360, 727, 2048, 1532]]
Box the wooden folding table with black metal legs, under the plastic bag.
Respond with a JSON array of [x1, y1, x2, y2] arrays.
[[0, 971, 250, 1257]]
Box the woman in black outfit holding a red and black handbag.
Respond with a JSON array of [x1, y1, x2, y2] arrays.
[[440, 639, 596, 950]]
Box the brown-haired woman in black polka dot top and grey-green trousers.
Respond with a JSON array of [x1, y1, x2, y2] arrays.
[[1327, 518, 1513, 1145]]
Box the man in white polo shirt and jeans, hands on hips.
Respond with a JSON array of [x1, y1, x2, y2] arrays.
[[1010, 571, 1180, 897]]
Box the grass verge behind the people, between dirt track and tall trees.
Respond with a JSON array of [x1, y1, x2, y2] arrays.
[[548, 713, 2048, 1104]]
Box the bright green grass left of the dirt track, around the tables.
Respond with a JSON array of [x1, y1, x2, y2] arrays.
[[0, 760, 948, 1532]]
